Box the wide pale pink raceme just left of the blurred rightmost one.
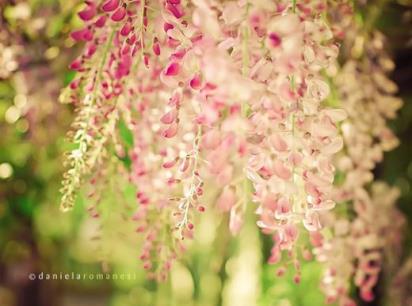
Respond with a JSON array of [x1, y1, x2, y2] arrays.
[[241, 1, 346, 279]]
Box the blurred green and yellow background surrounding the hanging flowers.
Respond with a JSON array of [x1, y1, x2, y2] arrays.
[[0, 0, 412, 306]]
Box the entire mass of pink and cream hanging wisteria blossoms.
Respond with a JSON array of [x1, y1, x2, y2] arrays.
[[61, 0, 406, 305]]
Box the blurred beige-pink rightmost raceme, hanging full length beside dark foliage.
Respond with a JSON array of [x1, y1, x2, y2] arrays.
[[316, 29, 403, 305]]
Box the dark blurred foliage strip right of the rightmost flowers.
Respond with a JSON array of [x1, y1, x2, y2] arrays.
[[376, 1, 412, 257]]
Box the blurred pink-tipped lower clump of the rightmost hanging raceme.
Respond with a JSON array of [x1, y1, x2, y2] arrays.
[[314, 182, 404, 306]]
